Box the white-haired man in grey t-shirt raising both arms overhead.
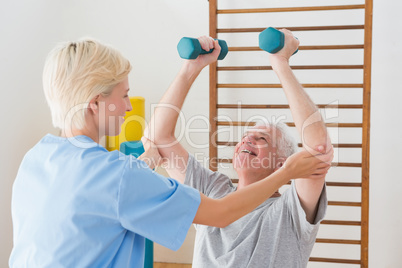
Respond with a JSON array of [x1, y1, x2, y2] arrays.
[[144, 29, 333, 268]]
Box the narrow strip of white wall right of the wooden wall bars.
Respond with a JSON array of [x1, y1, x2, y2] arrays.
[[369, 1, 402, 267]]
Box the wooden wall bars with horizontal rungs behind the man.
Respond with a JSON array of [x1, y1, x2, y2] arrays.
[[209, 0, 373, 267]]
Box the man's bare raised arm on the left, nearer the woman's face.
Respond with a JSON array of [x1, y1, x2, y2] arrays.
[[143, 37, 221, 183]]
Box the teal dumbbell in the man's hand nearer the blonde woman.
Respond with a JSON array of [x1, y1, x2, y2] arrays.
[[177, 37, 229, 60]]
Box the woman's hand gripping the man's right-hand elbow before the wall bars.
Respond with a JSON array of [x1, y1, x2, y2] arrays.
[[282, 147, 334, 179]]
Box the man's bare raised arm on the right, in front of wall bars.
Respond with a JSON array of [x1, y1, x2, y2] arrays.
[[269, 30, 332, 223]]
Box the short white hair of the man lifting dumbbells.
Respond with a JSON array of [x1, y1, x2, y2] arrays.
[[252, 120, 297, 158]]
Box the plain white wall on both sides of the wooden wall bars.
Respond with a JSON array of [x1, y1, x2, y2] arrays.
[[0, 0, 402, 267]]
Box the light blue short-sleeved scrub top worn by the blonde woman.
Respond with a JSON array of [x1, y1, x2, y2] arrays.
[[9, 134, 200, 267]]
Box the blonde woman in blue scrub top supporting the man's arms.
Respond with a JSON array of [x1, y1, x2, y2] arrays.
[[9, 39, 332, 268]]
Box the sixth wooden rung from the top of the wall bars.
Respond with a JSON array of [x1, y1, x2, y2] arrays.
[[216, 104, 363, 109]]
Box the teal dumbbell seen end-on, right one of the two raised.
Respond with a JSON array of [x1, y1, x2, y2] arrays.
[[258, 27, 299, 54]]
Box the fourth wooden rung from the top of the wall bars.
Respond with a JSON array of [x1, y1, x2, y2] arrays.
[[217, 65, 364, 71]]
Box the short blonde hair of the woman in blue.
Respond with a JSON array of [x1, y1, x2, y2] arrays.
[[43, 39, 131, 129]]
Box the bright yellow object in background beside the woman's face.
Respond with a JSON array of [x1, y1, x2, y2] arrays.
[[106, 97, 145, 151]]
